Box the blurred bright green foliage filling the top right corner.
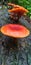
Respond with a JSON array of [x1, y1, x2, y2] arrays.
[[18, 0, 31, 18]]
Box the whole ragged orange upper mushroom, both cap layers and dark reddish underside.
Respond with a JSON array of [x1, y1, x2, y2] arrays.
[[8, 3, 29, 19]]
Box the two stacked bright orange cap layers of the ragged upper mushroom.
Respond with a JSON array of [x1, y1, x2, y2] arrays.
[[8, 3, 28, 13]]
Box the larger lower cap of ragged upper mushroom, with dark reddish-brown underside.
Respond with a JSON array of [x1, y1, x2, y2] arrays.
[[8, 7, 28, 19]]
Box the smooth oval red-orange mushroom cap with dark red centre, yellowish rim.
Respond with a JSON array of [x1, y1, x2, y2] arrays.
[[1, 24, 30, 38]]
